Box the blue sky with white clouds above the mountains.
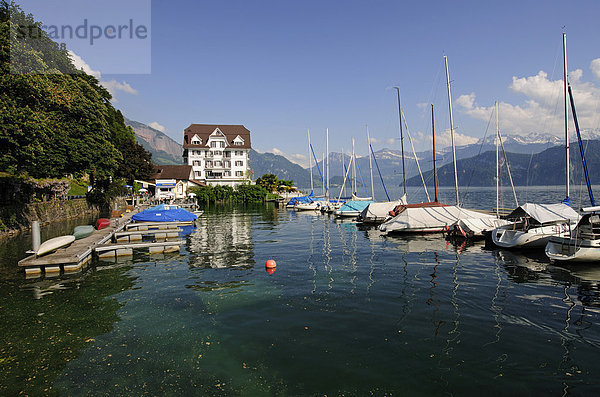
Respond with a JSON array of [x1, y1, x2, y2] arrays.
[[18, 0, 600, 165]]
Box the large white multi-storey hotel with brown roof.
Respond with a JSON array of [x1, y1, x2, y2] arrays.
[[183, 124, 251, 186]]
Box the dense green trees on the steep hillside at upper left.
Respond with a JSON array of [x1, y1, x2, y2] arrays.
[[0, 1, 152, 203]]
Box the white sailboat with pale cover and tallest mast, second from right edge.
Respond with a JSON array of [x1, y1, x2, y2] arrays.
[[492, 33, 579, 248]]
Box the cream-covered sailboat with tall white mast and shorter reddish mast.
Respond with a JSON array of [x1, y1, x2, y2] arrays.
[[379, 56, 494, 234]]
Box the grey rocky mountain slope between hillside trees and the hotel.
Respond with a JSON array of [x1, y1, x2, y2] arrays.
[[125, 117, 183, 165]]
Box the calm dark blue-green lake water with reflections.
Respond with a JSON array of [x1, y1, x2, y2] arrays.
[[0, 188, 600, 396]]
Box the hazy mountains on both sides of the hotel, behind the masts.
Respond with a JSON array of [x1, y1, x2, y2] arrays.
[[125, 119, 600, 188]]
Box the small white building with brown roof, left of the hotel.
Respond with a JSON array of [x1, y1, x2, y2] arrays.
[[151, 165, 206, 200]]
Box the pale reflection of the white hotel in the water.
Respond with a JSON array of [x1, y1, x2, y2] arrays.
[[188, 209, 254, 268]]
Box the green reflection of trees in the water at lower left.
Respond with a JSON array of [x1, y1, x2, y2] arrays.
[[0, 266, 135, 395]]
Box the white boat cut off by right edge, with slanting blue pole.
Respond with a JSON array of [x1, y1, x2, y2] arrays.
[[545, 86, 600, 262]]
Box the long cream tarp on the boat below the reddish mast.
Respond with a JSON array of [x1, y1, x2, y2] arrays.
[[379, 204, 495, 233]]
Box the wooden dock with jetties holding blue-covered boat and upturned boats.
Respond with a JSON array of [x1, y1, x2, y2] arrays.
[[18, 212, 193, 277]]
